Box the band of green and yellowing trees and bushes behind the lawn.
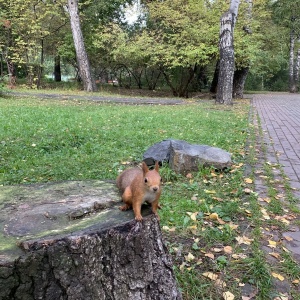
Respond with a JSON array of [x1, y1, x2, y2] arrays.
[[0, 0, 300, 102]]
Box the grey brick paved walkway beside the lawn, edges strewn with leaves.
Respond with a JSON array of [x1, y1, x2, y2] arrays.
[[252, 93, 300, 263]]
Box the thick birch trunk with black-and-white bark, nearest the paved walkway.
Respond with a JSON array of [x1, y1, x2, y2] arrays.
[[216, 0, 240, 105]]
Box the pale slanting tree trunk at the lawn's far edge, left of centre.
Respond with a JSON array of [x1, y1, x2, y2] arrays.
[[68, 0, 96, 92]]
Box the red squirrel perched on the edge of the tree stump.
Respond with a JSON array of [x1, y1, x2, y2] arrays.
[[117, 162, 162, 221]]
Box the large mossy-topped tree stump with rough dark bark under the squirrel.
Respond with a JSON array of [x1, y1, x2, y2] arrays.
[[0, 181, 182, 300]]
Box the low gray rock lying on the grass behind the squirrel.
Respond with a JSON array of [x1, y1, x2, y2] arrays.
[[143, 139, 231, 174]]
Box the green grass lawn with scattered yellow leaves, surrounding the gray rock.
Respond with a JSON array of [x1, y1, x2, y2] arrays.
[[0, 92, 299, 300]]
